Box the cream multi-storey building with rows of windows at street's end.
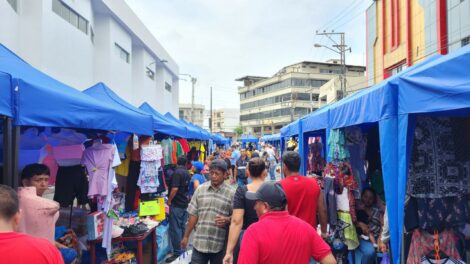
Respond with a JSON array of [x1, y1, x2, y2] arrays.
[[236, 60, 365, 136]]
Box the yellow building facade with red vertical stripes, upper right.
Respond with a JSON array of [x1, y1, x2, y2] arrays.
[[366, 0, 470, 85]]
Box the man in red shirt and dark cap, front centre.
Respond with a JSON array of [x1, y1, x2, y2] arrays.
[[238, 182, 336, 264]]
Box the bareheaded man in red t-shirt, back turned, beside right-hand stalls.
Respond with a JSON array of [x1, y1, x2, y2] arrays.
[[280, 151, 328, 238]]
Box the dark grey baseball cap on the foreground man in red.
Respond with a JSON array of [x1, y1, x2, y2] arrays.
[[245, 182, 287, 207]]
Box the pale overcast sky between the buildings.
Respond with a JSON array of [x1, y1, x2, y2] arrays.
[[126, 0, 371, 109]]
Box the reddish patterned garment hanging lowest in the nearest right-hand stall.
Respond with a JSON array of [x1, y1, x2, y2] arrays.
[[406, 229, 461, 264]]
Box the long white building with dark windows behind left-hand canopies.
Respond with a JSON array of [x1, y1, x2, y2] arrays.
[[0, 0, 179, 116]]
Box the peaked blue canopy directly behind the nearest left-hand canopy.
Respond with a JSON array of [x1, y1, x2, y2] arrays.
[[83, 82, 154, 135]]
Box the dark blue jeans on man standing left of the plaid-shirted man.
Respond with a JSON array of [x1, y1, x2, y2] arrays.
[[168, 206, 189, 255]]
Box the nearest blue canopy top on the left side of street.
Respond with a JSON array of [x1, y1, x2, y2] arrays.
[[0, 45, 143, 131]]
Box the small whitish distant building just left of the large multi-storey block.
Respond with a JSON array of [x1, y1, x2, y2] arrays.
[[212, 108, 240, 136]]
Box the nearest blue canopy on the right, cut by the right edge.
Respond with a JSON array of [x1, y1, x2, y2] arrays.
[[389, 46, 470, 264]]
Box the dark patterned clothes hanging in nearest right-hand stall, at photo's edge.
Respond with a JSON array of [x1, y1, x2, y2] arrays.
[[405, 116, 470, 263]]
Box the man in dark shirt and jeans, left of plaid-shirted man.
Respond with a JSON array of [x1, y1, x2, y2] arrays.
[[166, 155, 191, 263]]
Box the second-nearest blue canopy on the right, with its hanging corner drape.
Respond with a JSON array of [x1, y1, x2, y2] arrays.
[[299, 54, 437, 261]]
